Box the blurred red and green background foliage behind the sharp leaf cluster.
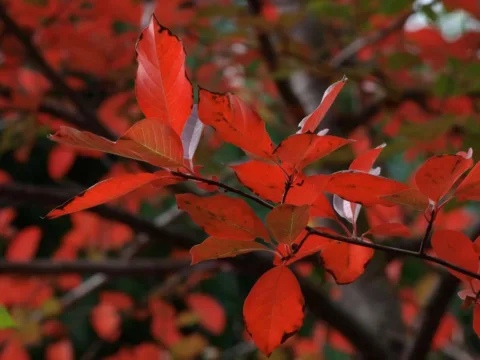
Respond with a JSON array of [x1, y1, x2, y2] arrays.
[[0, 0, 480, 360]]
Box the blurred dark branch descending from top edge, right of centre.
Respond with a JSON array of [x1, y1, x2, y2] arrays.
[[248, 0, 305, 122]]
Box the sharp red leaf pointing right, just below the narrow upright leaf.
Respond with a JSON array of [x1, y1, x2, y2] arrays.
[[274, 134, 350, 171]]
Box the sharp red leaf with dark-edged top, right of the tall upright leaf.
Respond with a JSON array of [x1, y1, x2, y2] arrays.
[[198, 89, 273, 158]]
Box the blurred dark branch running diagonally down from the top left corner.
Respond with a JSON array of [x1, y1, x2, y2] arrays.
[[0, 3, 112, 138]]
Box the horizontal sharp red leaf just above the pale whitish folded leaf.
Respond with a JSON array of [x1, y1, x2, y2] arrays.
[[325, 170, 408, 206]]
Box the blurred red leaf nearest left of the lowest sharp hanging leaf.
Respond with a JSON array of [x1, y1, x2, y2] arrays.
[[186, 293, 227, 335]]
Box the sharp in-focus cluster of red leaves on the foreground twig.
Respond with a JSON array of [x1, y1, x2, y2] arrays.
[[33, 14, 480, 355]]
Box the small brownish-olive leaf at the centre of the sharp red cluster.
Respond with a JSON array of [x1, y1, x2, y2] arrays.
[[266, 204, 310, 244]]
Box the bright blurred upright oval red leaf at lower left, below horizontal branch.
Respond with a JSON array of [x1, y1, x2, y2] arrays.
[[91, 303, 121, 342]]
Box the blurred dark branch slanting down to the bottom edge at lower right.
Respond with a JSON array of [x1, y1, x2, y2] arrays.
[[403, 273, 459, 360]]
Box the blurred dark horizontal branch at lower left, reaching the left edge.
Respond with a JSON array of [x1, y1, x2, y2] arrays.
[[0, 259, 190, 276]]
